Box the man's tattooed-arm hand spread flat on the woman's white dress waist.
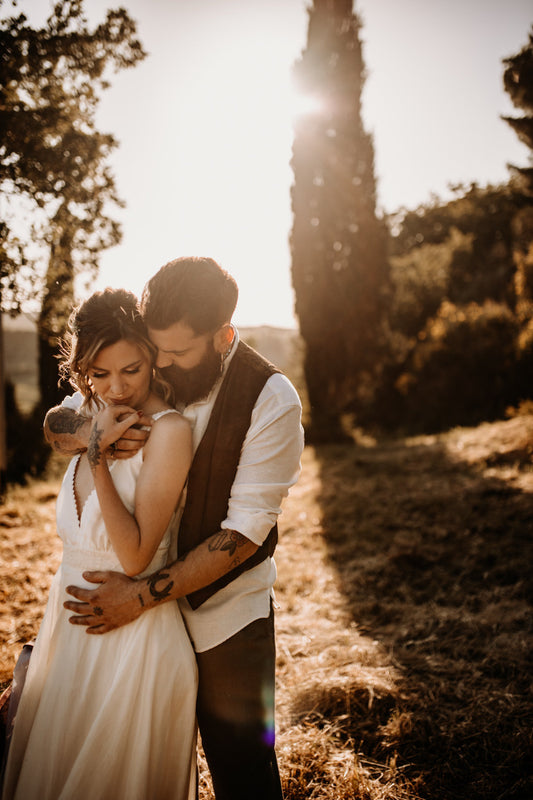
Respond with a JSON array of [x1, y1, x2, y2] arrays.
[[63, 572, 144, 634]]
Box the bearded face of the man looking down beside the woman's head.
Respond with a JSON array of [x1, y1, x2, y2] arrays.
[[149, 322, 221, 405]]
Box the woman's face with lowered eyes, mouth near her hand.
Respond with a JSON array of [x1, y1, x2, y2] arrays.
[[88, 339, 152, 409]]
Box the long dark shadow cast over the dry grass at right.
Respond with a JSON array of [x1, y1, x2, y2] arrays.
[[300, 437, 533, 800]]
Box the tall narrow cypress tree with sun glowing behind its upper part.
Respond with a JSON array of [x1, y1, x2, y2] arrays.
[[291, 0, 388, 440]]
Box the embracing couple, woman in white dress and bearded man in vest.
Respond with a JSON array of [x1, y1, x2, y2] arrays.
[[2, 258, 303, 800]]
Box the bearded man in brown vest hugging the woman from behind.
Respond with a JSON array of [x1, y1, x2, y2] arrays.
[[45, 258, 303, 800]]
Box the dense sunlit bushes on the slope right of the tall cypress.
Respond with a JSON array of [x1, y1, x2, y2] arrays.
[[366, 178, 533, 432]]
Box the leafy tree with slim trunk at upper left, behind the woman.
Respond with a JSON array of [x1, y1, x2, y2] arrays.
[[0, 0, 145, 456]]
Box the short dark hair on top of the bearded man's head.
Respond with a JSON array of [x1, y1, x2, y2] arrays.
[[141, 256, 239, 334]]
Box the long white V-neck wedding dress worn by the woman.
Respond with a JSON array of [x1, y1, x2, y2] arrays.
[[2, 412, 197, 800]]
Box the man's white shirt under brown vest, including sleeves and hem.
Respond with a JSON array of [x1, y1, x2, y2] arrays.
[[58, 331, 304, 652]]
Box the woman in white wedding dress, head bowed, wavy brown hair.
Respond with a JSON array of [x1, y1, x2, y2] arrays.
[[2, 289, 197, 800]]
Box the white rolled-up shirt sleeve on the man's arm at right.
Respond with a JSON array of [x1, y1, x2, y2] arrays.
[[222, 373, 304, 545]]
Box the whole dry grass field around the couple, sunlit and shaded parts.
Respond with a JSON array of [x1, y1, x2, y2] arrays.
[[0, 416, 533, 800]]
